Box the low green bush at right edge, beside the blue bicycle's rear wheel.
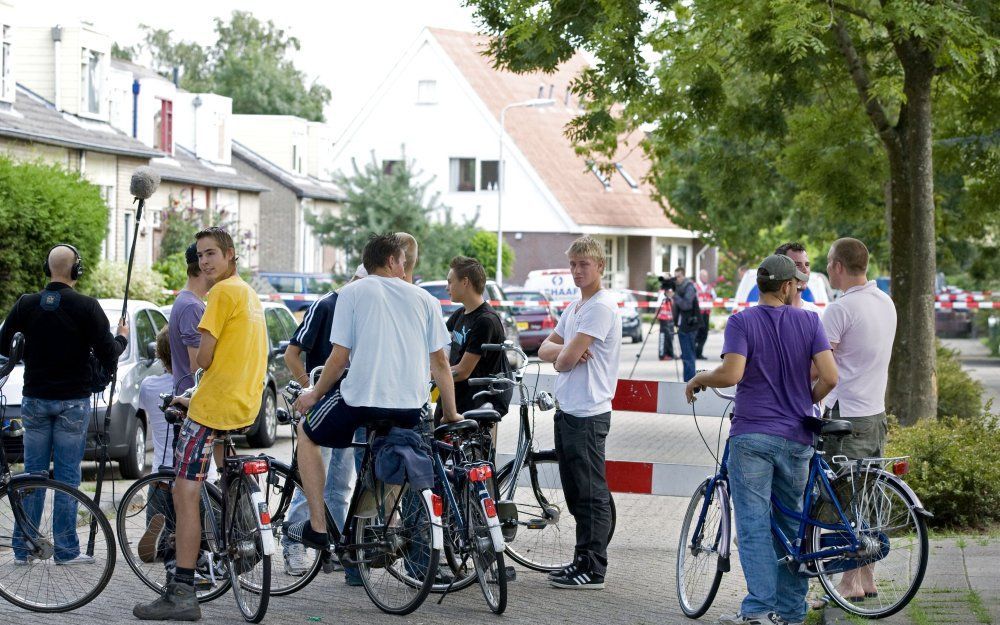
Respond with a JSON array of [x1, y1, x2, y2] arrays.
[[886, 414, 1000, 529]]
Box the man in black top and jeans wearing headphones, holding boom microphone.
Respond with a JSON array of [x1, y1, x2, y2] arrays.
[[0, 243, 128, 565]]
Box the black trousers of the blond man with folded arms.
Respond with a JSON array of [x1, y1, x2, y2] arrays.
[[555, 410, 611, 575]]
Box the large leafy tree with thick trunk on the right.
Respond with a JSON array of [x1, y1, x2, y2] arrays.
[[466, 0, 1000, 423]]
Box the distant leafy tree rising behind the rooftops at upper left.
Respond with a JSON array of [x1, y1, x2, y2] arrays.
[[133, 11, 331, 121]]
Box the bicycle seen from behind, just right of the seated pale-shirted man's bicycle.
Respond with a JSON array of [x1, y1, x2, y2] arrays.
[[421, 398, 508, 614]]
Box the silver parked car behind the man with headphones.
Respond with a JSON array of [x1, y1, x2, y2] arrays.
[[4, 299, 167, 479]]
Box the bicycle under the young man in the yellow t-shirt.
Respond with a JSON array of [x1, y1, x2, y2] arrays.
[[116, 371, 274, 623]]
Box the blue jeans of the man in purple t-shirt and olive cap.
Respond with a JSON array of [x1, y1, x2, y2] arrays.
[[729, 434, 813, 622]]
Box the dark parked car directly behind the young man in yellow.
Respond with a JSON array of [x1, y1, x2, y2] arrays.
[[161, 301, 298, 447]]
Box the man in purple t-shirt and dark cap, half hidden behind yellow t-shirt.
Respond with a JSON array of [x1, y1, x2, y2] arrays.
[[168, 243, 210, 395]]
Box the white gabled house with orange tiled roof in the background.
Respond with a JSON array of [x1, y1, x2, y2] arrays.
[[334, 28, 715, 289]]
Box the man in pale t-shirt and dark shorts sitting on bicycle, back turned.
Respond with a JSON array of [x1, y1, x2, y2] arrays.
[[287, 234, 461, 548]]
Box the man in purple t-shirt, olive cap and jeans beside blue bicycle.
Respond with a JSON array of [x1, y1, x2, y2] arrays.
[[686, 256, 837, 625]]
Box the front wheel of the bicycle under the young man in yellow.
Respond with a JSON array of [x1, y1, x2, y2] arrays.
[[115, 471, 229, 603]]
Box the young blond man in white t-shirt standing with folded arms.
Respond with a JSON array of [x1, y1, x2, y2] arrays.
[[538, 237, 622, 589]]
